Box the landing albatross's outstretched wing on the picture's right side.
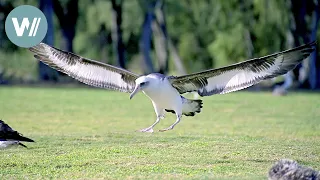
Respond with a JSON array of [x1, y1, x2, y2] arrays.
[[168, 42, 316, 96]]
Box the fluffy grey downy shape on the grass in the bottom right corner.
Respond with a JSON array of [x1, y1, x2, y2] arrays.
[[268, 159, 320, 180]]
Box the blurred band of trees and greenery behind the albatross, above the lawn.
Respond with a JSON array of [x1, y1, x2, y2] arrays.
[[0, 0, 320, 89]]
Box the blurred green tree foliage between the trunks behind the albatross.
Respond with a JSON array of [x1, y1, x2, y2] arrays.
[[0, 0, 320, 87]]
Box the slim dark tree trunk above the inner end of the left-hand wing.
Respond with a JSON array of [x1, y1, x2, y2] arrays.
[[111, 0, 125, 68]]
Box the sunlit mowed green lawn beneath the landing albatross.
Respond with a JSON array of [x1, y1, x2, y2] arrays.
[[0, 87, 320, 179]]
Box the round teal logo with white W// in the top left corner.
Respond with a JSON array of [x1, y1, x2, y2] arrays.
[[5, 5, 48, 48]]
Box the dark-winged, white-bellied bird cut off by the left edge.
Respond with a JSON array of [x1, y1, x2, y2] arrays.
[[0, 120, 34, 148]]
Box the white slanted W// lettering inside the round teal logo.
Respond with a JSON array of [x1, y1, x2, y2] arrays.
[[11, 17, 41, 37]]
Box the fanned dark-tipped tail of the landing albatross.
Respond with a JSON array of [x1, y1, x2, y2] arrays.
[[166, 96, 202, 116]]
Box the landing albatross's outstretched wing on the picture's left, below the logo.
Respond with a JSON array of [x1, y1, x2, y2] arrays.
[[29, 43, 138, 93]]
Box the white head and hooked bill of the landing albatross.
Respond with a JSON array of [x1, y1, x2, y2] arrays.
[[130, 75, 159, 99]]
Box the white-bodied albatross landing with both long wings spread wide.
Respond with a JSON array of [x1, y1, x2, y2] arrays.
[[29, 42, 316, 132]]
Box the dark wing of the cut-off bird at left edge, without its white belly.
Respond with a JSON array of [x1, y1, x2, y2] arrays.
[[0, 120, 34, 142]]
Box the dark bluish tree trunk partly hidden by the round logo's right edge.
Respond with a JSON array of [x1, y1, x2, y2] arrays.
[[39, 0, 58, 81]]
